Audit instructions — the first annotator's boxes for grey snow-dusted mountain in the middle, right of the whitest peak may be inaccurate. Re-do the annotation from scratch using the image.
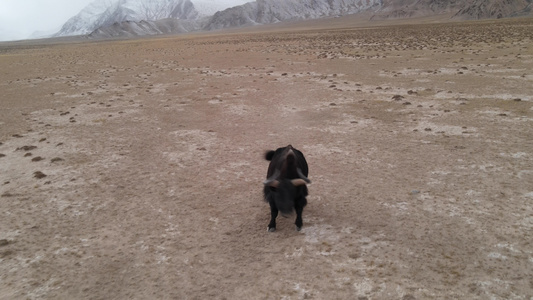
[204,0,383,30]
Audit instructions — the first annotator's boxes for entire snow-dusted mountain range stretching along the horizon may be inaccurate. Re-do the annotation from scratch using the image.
[58,0,533,38]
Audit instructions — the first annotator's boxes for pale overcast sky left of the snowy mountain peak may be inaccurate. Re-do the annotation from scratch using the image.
[0,0,93,41]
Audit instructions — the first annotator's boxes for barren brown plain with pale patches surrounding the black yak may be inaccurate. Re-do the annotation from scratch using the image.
[0,19,533,300]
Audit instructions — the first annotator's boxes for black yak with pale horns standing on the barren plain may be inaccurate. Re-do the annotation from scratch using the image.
[263,145,311,232]
